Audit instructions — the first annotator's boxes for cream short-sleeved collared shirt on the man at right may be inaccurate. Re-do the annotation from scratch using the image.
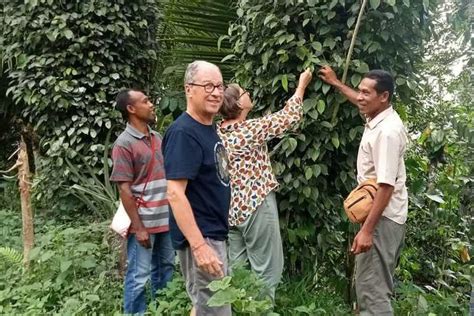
[357,107,408,224]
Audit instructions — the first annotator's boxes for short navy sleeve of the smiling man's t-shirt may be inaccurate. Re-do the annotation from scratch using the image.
[163,130,203,180]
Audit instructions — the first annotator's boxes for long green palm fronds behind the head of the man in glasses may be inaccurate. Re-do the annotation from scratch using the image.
[158,0,237,117]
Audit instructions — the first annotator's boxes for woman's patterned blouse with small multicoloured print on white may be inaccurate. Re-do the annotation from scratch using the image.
[217,95,303,226]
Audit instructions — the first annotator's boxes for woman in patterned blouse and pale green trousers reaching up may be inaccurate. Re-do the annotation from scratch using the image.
[218,70,312,301]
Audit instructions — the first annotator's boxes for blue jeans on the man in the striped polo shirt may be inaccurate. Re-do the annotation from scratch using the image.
[124,232,175,314]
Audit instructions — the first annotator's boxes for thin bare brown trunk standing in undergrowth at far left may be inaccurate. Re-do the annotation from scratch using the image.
[18,135,35,268]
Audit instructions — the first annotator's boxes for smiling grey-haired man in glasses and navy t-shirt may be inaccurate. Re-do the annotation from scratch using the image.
[163,61,231,316]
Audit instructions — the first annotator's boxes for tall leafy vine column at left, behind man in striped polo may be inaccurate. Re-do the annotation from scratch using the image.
[1,0,158,212]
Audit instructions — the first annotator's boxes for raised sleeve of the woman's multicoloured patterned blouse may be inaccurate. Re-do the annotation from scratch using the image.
[260,96,303,141]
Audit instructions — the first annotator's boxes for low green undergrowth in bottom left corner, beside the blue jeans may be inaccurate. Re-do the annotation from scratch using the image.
[0,217,122,315]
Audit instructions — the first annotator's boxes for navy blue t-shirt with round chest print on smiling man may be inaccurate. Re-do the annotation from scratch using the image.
[162,112,230,249]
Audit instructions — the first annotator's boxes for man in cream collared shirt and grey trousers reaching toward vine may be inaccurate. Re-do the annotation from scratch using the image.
[319,66,408,316]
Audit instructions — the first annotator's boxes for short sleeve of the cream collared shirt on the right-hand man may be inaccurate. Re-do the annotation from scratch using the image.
[372,130,405,186]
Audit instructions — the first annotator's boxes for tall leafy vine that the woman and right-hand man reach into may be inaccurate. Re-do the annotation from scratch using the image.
[224,0,442,292]
